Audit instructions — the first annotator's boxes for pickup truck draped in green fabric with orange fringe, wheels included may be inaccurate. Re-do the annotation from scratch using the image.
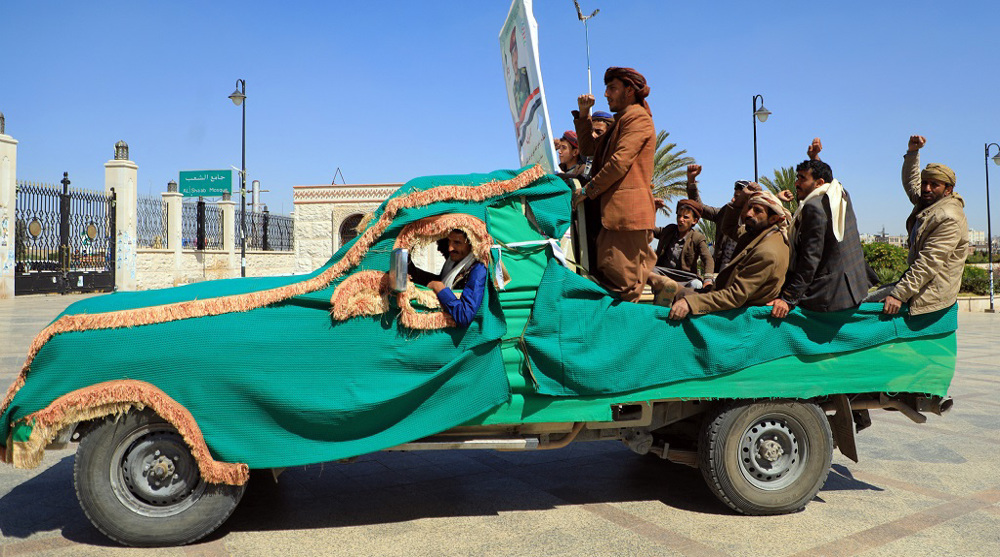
[0,168,957,546]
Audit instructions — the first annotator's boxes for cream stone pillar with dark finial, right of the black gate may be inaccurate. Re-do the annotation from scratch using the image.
[104,141,139,290]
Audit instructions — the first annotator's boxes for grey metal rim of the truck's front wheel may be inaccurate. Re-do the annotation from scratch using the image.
[110,423,206,517]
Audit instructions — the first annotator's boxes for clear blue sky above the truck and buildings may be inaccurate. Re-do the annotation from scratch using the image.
[0,0,1000,234]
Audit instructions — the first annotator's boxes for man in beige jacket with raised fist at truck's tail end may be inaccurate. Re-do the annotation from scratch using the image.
[882,135,969,315]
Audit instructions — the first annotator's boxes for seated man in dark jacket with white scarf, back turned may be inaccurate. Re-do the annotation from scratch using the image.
[768,138,871,318]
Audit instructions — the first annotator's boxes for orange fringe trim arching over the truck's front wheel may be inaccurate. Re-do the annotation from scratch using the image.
[5,379,250,485]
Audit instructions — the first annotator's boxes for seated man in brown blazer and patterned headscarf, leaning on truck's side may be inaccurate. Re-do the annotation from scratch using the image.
[670,191,789,320]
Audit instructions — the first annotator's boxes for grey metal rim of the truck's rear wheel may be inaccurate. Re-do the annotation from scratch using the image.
[739,414,809,491]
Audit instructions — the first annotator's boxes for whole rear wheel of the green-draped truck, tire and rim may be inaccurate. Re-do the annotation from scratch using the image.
[698,401,833,515]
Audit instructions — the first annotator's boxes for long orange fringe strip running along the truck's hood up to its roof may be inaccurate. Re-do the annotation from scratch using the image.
[0,165,544,422]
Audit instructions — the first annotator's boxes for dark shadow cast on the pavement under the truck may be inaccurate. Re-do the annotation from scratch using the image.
[0,443,881,545]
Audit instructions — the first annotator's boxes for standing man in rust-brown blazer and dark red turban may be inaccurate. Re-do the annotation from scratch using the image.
[574,68,656,302]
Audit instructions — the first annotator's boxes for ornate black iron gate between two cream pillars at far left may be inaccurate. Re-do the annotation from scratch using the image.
[14,172,115,295]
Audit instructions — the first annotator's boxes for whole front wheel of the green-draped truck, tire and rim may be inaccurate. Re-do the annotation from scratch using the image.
[73,410,246,547]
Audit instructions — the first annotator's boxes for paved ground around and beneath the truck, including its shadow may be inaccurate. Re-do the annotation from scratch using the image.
[0,297,1000,557]
